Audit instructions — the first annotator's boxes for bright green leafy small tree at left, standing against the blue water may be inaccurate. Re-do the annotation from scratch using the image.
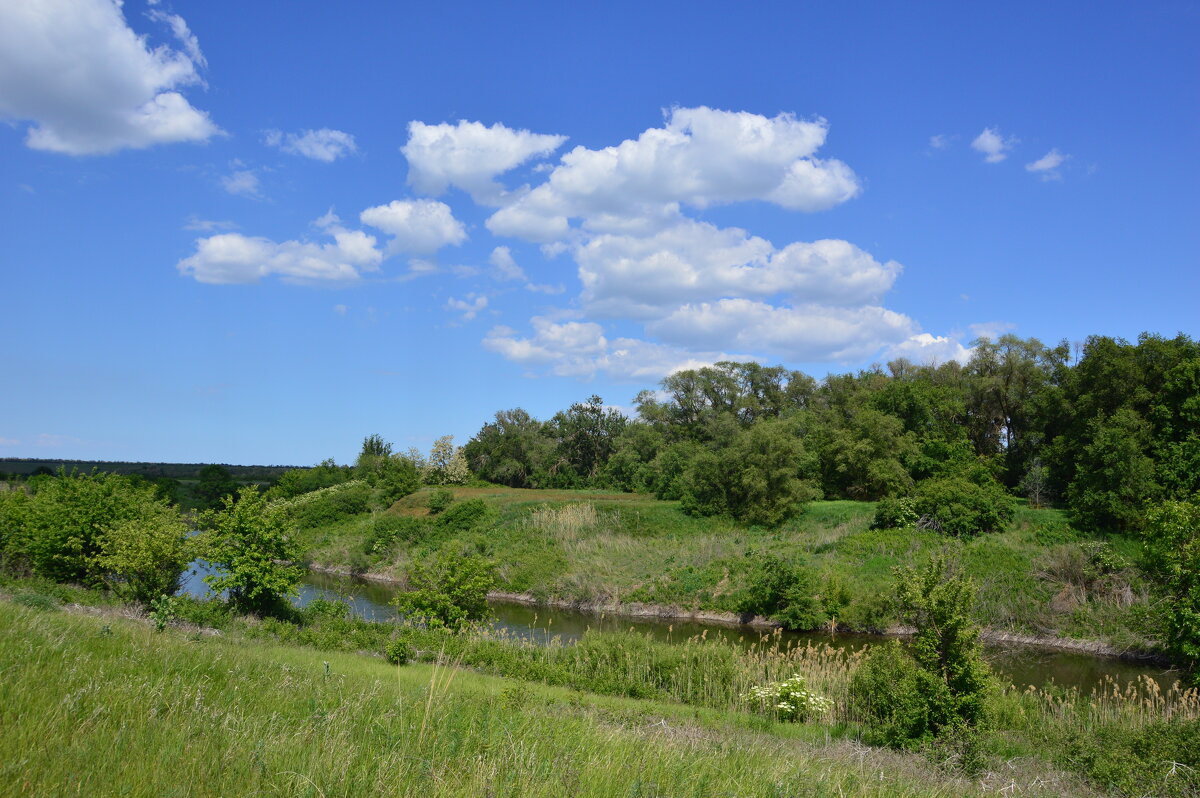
[200,487,302,612]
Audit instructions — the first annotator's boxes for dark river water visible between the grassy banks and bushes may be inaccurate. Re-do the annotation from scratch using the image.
[180,563,1178,692]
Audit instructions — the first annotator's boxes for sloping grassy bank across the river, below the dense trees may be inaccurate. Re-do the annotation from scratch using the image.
[297,487,1162,650]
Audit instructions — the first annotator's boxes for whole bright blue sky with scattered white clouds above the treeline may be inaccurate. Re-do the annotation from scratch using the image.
[0,0,1200,464]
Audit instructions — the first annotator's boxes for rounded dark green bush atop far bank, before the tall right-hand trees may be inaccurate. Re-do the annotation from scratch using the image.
[912,476,1016,535]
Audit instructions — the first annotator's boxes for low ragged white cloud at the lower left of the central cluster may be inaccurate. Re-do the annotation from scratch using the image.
[484,317,749,383]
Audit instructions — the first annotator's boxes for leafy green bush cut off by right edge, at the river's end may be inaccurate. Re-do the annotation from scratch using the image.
[1142,494,1200,667]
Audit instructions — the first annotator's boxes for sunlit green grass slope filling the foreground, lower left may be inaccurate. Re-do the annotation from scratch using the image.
[0,602,1091,798]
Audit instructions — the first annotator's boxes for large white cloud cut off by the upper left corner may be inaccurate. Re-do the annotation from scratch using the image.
[0,0,221,155]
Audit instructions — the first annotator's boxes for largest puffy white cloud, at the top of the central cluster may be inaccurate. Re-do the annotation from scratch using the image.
[487,107,859,241]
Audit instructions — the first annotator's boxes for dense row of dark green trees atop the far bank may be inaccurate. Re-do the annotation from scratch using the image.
[463,334,1200,534]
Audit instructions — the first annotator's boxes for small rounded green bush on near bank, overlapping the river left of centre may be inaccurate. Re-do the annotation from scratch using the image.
[392,550,496,630]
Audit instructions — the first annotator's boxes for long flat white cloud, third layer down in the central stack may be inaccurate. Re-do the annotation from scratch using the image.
[646,299,916,362]
